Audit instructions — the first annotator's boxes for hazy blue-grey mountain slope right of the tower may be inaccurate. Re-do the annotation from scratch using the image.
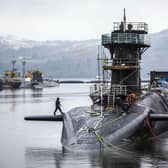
[142,29,168,77]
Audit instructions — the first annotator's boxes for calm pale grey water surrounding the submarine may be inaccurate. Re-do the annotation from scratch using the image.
[0,84,168,168]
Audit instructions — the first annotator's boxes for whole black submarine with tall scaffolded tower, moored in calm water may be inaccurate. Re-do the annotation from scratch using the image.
[61,9,168,151]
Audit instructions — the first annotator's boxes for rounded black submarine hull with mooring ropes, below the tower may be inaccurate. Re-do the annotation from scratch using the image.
[62,92,168,151]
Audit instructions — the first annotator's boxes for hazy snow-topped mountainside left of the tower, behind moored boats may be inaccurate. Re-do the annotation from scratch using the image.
[0,37,100,78]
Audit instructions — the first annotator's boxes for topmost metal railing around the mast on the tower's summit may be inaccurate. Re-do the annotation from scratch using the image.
[114,22,148,33]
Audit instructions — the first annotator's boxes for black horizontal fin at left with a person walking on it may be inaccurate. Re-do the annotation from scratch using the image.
[24,115,63,121]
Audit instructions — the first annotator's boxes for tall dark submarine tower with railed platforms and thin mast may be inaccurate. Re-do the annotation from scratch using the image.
[101,9,150,109]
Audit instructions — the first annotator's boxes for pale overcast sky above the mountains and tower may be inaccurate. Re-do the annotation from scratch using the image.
[0,0,168,40]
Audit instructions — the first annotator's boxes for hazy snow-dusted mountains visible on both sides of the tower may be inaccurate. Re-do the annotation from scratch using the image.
[0,29,168,78]
